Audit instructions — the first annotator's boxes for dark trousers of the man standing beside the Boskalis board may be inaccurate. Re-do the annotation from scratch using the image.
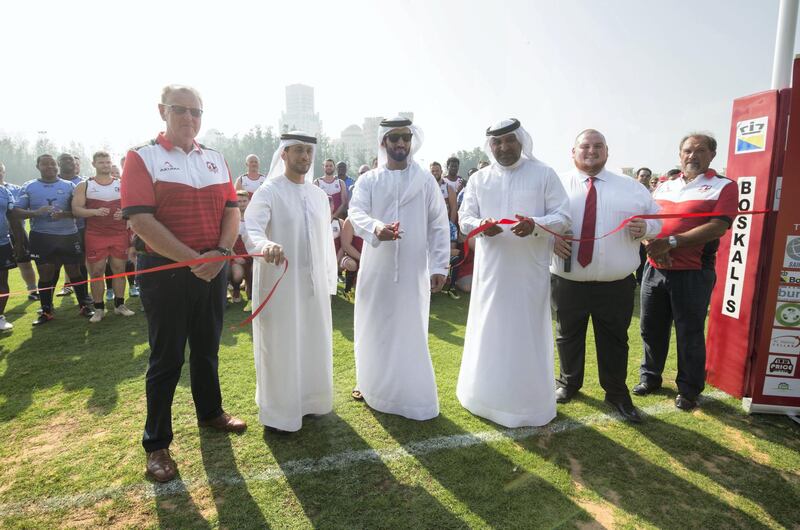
[639,263,717,399]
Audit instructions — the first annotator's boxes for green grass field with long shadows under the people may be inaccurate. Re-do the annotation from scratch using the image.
[0,271,800,528]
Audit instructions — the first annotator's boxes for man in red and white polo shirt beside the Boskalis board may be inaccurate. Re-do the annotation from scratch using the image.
[633,134,738,410]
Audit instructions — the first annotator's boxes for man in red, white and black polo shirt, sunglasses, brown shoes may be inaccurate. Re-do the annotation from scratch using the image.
[122,85,247,482]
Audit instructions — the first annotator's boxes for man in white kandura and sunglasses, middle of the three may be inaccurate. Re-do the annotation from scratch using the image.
[349,118,454,420]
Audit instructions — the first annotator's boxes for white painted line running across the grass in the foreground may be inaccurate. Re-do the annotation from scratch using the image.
[0,391,727,517]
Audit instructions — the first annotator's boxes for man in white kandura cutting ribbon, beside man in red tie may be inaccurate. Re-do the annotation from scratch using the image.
[456,119,570,427]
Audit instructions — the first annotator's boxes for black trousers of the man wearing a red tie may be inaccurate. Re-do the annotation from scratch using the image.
[550,274,636,403]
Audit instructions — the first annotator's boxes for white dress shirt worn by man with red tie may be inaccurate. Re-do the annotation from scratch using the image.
[550,169,661,282]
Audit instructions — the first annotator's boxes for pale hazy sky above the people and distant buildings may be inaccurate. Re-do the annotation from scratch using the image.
[0,0,800,170]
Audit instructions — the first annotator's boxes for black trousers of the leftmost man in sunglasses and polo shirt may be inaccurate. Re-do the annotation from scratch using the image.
[136,255,228,452]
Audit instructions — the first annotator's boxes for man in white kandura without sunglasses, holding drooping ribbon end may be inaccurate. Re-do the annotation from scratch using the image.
[244,132,336,431]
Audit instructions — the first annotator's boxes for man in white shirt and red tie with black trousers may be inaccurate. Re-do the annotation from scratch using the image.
[550,129,661,423]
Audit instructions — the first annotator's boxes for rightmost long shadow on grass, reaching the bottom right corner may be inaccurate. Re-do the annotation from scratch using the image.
[642,404,800,528]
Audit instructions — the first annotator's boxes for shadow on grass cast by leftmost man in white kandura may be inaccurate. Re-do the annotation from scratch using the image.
[264,413,467,528]
